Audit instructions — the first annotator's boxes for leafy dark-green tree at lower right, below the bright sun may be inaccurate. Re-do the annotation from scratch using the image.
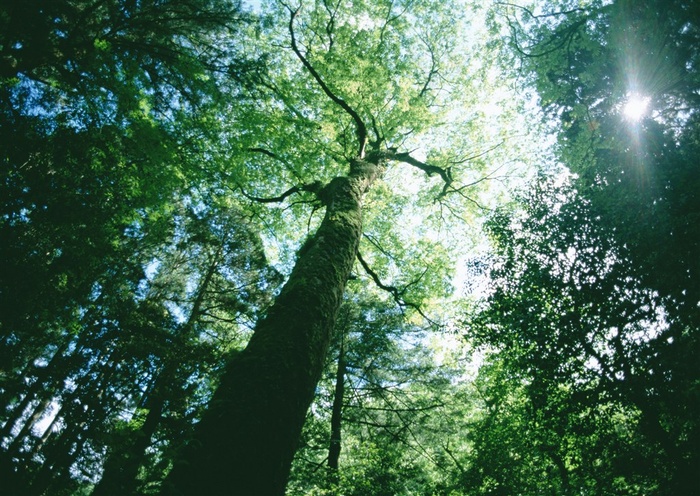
[469,181,680,494]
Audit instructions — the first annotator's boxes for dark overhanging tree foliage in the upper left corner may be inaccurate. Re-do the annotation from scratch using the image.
[0,1,258,384]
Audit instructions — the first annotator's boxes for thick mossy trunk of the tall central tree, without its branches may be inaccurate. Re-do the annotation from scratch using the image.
[163,159,383,496]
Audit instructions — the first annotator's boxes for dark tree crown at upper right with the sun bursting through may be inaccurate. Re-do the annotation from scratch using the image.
[494,1,700,306]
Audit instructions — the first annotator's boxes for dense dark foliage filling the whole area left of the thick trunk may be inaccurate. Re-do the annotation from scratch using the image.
[0,1,279,494]
